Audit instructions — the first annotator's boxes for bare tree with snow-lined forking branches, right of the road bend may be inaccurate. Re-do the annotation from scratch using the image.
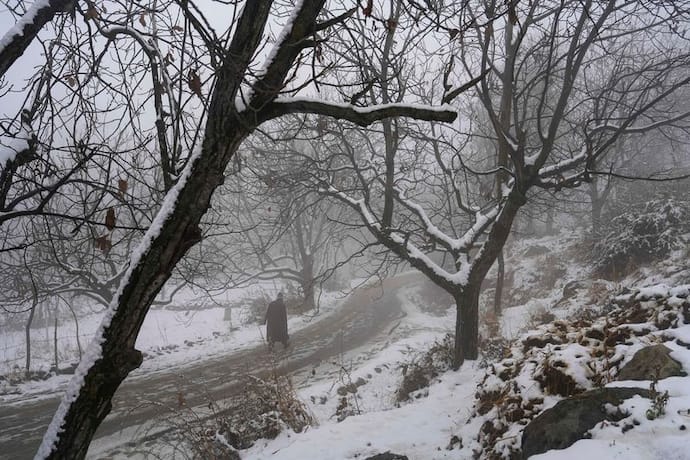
[310,1,690,367]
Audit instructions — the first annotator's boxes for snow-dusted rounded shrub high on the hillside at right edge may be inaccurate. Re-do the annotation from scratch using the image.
[592,199,690,279]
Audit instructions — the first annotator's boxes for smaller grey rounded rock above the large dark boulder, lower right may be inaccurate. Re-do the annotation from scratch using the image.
[617,344,687,380]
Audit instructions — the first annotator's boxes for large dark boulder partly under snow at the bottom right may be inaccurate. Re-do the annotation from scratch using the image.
[522,388,649,459]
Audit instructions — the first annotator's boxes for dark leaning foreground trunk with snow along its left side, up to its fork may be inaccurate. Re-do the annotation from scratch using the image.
[37,47,264,459]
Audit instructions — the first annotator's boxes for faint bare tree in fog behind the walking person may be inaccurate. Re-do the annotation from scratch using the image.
[209,135,347,310]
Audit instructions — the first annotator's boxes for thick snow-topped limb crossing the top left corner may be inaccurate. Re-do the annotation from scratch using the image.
[0,0,75,77]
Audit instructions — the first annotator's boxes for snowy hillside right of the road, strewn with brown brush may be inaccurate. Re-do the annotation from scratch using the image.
[234,235,690,460]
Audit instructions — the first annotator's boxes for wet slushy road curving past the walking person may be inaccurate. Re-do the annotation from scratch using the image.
[0,274,420,460]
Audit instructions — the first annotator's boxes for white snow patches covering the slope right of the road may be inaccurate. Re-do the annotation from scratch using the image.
[241,235,690,460]
